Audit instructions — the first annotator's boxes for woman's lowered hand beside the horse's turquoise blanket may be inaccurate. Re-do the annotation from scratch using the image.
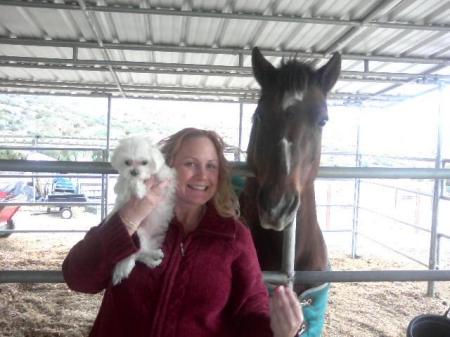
[270,286,303,337]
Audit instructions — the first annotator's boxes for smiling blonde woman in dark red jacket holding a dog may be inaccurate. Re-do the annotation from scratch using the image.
[63,128,303,337]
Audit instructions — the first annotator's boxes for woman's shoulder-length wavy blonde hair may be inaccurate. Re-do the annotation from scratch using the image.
[159,128,239,218]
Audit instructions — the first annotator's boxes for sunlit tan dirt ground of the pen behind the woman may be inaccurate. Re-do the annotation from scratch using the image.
[0,211,450,337]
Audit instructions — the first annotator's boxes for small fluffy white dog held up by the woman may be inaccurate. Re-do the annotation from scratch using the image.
[111,136,176,285]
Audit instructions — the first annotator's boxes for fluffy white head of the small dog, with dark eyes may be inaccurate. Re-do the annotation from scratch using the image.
[111,137,164,180]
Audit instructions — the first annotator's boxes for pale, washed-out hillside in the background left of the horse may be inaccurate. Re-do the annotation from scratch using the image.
[0,95,244,160]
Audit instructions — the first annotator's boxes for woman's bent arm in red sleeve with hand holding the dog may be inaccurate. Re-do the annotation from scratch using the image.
[62,177,173,293]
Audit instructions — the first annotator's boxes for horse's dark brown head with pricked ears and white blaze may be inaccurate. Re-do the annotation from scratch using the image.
[247,48,341,231]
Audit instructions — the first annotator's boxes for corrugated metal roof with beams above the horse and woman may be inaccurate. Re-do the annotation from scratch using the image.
[0,0,450,106]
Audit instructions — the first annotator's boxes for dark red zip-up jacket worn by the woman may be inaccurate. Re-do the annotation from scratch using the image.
[62,206,272,337]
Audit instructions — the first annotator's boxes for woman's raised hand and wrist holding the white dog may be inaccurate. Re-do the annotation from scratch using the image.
[119,177,169,235]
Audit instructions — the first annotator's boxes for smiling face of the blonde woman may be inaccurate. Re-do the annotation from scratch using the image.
[173,136,219,207]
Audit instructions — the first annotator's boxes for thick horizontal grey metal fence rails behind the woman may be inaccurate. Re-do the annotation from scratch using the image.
[0,160,450,283]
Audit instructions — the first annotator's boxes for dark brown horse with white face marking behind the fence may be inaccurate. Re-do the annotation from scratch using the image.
[240,47,341,294]
